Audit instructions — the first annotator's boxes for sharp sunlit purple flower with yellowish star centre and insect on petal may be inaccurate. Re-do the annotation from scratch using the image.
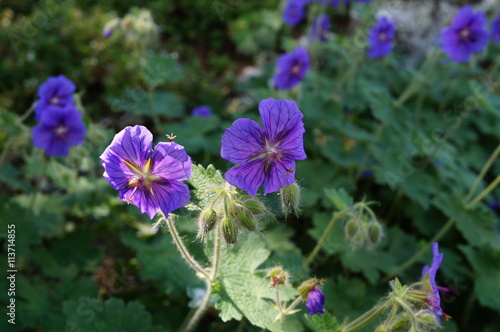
[100,126,191,219]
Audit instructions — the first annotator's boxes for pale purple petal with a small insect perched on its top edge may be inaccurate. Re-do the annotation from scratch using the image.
[152,142,192,181]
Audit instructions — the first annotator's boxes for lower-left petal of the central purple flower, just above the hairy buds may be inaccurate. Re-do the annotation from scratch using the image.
[224,158,266,196]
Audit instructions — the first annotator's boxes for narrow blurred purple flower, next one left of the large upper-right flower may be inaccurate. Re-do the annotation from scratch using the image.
[368,16,396,59]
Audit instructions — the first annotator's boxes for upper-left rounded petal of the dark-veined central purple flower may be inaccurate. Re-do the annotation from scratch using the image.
[220,119,265,164]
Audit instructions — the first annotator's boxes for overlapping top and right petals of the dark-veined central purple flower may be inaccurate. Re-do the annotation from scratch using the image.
[259,98,306,160]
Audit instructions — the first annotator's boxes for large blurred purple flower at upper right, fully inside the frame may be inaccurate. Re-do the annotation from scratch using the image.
[441,6,489,62]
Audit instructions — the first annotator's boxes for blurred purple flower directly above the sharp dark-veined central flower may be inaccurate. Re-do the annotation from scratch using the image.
[274,47,311,90]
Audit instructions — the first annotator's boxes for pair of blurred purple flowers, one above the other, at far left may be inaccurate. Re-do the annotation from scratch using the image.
[31,75,87,156]
